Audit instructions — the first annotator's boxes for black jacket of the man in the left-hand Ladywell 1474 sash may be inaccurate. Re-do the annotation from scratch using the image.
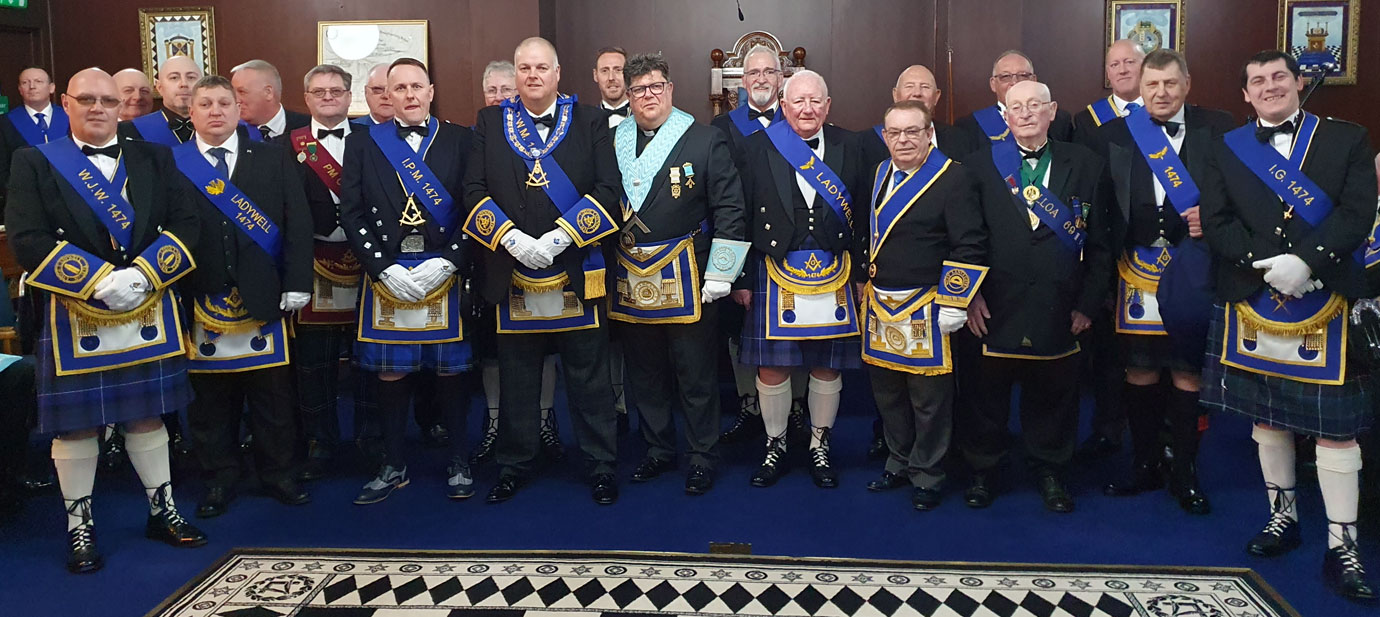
[178,137,312,322]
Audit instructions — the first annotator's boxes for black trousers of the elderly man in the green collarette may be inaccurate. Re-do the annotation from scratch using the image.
[959,353,1082,473]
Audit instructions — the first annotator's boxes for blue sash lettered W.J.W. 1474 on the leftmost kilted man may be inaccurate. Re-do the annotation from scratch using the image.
[37,137,134,248]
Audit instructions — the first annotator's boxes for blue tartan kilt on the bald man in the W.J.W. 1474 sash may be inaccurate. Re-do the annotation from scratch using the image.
[35,322,192,433]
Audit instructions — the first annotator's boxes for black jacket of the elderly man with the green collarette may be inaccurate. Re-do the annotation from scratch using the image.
[965,139,1112,355]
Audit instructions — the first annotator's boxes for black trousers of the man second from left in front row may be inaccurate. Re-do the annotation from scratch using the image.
[186,366,297,487]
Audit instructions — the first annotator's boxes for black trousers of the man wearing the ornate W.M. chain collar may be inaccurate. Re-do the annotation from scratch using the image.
[494,306,609,478]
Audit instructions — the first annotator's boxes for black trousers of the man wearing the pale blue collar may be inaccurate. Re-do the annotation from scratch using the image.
[613,302,719,469]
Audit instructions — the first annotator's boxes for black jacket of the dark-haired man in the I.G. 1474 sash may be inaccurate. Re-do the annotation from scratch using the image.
[1198,119,1376,302]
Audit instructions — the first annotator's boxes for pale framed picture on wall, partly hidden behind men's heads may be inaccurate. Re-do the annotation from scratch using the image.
[316,19,431,116]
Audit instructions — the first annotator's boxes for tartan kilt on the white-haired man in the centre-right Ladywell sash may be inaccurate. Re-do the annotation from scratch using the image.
[738,268,863,370]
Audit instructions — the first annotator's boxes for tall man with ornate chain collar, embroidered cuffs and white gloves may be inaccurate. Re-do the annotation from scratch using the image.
[465,37,621,504]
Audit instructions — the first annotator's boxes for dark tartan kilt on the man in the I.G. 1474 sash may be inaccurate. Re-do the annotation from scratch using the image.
[1199,304,1374,440]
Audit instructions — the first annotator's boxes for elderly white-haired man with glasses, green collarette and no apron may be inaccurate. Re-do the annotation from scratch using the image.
[959,81,1111,512]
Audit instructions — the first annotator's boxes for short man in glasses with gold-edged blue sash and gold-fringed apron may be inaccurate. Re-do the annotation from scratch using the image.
[854,101,987,511]
